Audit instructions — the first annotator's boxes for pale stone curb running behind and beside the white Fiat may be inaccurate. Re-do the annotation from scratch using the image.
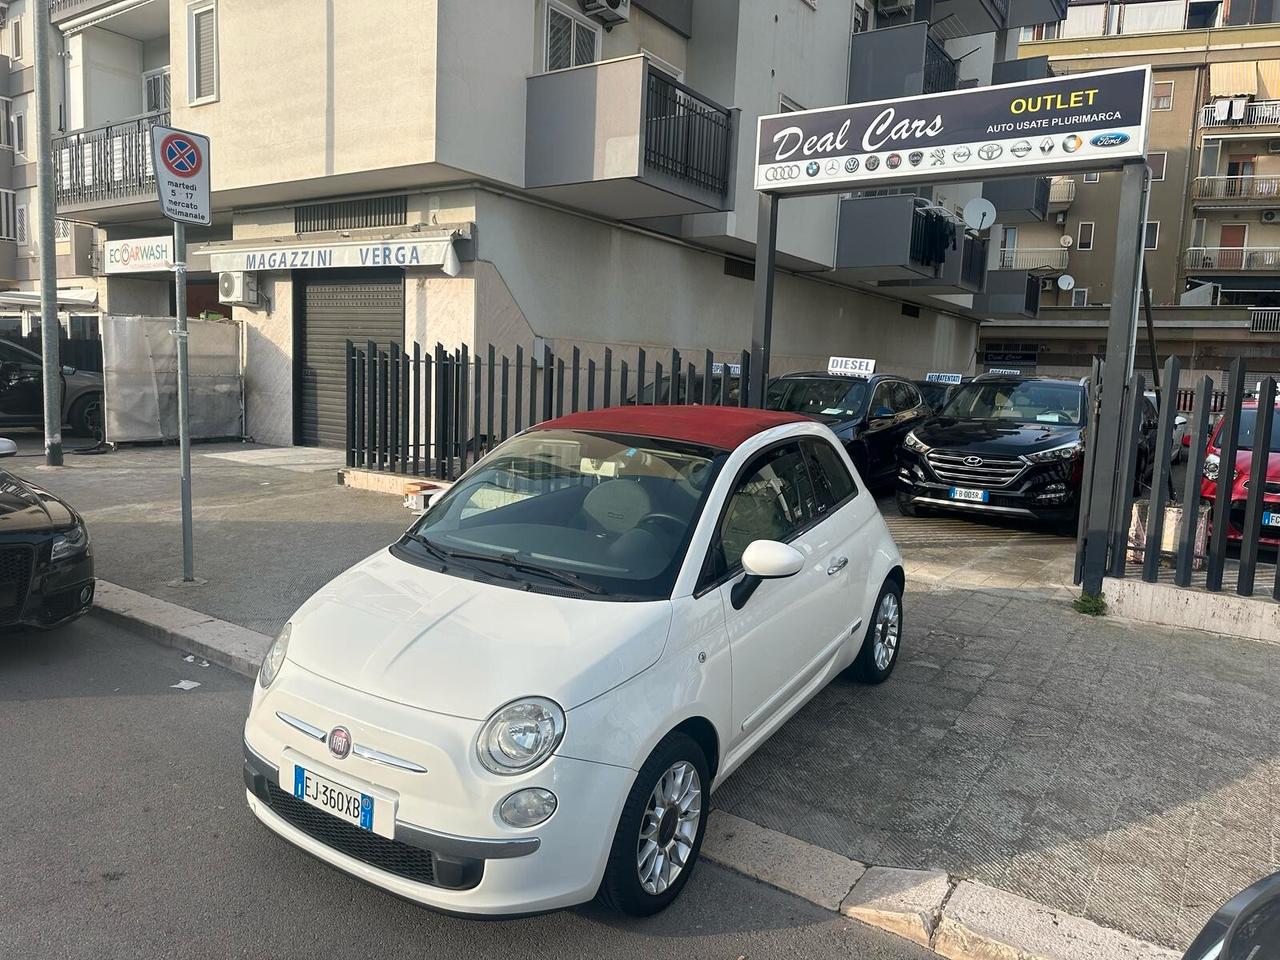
[92,580,1180,960]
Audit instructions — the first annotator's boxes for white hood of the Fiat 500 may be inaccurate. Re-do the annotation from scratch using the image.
[288,550,672,721]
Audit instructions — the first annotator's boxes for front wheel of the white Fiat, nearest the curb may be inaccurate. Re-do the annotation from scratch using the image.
[596,731,710,916]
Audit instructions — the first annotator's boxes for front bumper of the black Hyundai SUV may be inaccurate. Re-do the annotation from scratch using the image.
[897,449,1080,521]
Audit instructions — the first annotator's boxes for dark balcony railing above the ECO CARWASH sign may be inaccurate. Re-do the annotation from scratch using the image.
[54,111,169,207]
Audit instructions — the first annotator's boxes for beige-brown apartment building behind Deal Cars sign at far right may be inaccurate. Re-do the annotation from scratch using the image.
[979,0,1280,376]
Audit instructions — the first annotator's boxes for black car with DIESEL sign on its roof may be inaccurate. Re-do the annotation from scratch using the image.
[764,371,932,486]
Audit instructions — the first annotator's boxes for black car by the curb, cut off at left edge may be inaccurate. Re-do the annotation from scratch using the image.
[0,440,93,634]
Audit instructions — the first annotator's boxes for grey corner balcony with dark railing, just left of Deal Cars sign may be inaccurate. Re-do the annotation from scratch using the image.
[525,55,735,220]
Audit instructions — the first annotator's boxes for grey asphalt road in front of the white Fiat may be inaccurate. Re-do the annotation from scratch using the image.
[0,618,933,960]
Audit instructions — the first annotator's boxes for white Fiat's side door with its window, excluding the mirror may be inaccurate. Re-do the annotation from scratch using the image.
[710,440,850,744]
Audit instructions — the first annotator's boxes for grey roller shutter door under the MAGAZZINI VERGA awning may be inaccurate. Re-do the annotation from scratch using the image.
[294,270,404,447]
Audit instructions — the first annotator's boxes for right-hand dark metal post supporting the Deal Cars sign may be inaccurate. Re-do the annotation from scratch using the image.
[1080,161,1149,596]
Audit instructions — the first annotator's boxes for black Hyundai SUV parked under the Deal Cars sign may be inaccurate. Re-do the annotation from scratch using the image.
[897,375,1156,526]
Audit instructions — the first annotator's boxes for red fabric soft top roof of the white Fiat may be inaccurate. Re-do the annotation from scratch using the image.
[535,404,813,451]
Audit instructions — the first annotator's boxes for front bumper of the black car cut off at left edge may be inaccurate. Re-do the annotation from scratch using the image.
[0,545,95,630]
